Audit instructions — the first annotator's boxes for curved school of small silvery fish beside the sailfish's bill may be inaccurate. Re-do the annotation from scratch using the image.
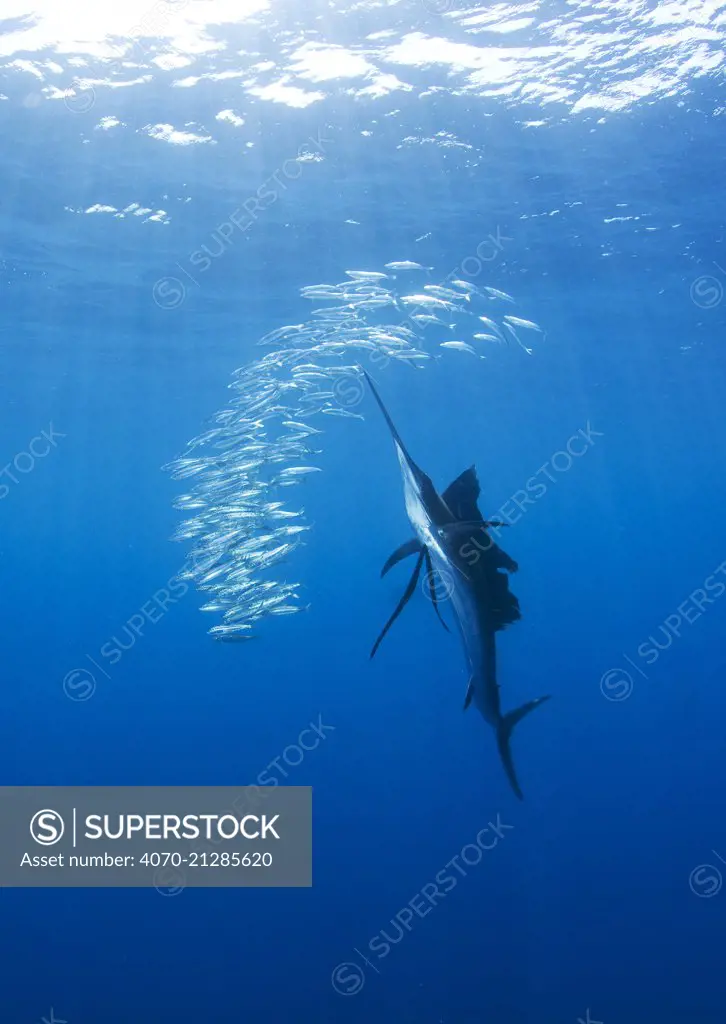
[164,260,540,643]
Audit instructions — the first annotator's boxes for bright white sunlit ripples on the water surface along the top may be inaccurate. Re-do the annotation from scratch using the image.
[0,0,726,112]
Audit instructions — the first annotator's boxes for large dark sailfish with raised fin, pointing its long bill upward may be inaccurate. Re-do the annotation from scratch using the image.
[362,370,550,800]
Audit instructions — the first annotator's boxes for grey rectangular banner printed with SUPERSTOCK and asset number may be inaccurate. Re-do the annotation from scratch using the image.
[0,785,312,895]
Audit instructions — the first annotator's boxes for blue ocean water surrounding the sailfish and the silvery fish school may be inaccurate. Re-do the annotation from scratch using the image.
[0,0,726,1024]
